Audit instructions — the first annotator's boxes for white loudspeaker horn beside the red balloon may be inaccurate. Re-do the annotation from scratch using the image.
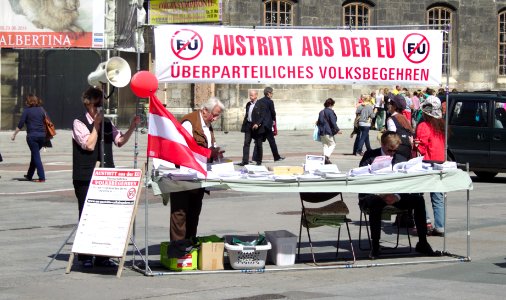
[88,56,132,87]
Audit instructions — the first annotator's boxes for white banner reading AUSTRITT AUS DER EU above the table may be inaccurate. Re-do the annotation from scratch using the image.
[155,25,443,85]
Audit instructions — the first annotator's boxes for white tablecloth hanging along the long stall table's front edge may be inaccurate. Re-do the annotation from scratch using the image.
[152,169,473,195]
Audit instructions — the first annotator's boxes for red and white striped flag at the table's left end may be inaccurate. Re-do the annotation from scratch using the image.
[147,95,211,177]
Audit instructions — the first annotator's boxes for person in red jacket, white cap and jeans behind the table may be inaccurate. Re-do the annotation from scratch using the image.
[415,96,445,236]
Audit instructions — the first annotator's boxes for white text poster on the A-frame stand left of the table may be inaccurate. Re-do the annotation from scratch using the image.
[72,168,142,257]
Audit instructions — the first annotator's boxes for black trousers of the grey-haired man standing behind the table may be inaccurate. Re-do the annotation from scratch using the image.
[170,189,204,241]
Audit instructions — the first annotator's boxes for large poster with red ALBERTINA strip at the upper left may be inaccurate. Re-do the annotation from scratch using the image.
[0,0,105,48]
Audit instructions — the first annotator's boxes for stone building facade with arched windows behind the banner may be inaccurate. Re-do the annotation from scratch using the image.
[1,0,506,130]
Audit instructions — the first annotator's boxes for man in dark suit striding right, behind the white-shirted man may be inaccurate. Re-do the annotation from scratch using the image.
[253,87,285,164]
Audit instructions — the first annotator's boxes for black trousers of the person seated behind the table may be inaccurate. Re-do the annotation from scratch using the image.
[359,194,427,244]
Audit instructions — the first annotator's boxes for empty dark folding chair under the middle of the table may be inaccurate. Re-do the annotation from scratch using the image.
[297,193,356,265]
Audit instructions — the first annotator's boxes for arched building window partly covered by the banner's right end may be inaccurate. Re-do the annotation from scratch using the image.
[427,6,453,75]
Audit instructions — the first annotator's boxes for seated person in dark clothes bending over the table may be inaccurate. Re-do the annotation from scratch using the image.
[358,131,440,259]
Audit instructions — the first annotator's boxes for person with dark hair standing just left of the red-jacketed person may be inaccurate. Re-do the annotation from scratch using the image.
[387,94,413,160]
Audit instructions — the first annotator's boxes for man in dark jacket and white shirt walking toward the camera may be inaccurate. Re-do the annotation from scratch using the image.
[239,90,265,166]
